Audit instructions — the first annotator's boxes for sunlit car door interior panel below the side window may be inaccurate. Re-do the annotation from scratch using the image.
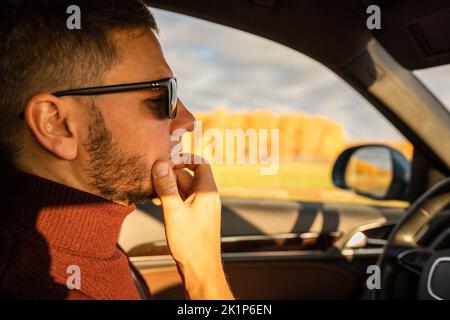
[120,198,403,299]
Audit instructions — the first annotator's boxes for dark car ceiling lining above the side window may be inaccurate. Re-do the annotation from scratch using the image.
[147,0,450,71]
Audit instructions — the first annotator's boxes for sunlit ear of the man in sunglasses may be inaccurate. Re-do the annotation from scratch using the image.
[24,93,78,160]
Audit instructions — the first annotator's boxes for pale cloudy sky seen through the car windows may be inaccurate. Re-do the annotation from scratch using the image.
[152,9,450,141]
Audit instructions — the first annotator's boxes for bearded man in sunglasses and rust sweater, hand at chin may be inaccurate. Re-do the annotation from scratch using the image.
[0,0,233,299]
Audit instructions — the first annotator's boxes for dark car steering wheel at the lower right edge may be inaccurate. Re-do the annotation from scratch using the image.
[372,178,450,300]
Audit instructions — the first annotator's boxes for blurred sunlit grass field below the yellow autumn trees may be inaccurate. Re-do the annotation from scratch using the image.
[213,162,407,206]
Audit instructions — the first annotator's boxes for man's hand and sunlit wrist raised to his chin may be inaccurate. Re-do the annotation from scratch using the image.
[152,156,233,299]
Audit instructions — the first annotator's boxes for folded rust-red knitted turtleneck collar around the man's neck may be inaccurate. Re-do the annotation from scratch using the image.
[0,168,135,258]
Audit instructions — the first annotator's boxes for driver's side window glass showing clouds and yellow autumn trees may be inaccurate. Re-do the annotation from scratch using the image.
[153,10,412,205]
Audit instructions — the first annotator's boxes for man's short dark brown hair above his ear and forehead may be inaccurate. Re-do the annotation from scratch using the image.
[0,0,157,162]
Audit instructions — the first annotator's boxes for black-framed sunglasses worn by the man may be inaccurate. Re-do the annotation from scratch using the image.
[19,77,178,119]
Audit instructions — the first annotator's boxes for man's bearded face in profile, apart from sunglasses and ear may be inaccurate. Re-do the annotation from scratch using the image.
[76,31,195,203]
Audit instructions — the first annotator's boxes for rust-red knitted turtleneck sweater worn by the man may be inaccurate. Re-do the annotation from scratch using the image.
[0,169,140,299]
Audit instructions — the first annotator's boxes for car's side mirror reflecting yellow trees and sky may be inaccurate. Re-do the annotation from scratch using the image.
[333,144,411,200]
